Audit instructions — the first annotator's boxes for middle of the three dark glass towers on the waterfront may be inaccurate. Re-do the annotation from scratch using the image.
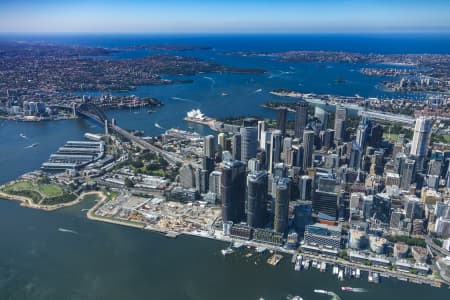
[247,172,268,228]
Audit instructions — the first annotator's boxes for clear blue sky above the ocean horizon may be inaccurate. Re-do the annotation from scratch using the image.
[0,0,450,33]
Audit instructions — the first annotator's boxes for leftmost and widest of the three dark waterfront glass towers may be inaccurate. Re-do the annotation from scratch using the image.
[220,160,246,223]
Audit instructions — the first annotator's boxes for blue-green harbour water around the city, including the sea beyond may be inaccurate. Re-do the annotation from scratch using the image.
[0,36,450,300]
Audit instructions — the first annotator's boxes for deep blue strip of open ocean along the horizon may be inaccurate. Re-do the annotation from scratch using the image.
[0,33,450,53]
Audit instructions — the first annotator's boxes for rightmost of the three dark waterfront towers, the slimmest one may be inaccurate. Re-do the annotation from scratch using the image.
[273,178,290,234]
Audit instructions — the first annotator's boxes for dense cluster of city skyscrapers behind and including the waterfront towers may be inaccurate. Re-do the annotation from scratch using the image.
[178,102,450,252]
